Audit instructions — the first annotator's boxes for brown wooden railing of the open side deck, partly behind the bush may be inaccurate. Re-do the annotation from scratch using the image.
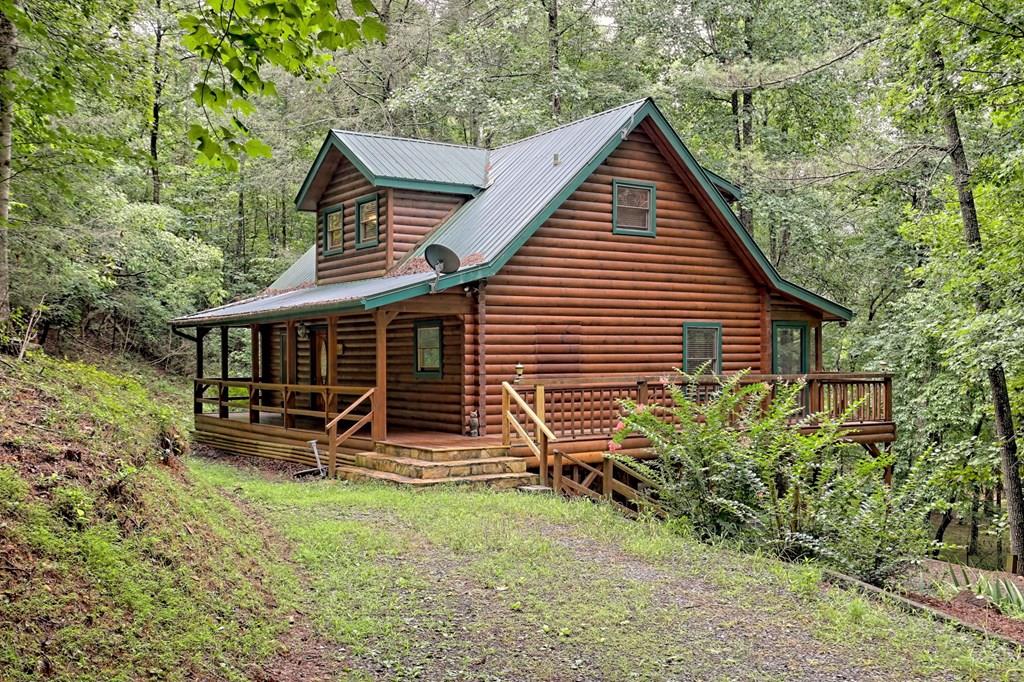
[503,373,892,440]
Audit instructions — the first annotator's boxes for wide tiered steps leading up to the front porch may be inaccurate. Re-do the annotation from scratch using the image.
[338,442,538,489]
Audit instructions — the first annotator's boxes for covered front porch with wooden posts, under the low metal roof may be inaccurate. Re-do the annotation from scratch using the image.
[179,295,476,470]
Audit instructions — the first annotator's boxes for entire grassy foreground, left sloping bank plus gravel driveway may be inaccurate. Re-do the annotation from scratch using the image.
[0,354,1024,682]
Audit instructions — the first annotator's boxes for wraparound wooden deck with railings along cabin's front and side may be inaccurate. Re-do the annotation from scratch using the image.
[195,373,896,475]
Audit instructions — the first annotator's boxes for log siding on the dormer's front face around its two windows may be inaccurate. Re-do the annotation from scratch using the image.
[316,159,388,284]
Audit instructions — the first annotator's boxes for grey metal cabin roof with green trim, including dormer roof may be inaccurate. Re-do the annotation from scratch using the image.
[174,98,853,326]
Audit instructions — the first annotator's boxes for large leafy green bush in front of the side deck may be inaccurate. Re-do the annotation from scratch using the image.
[613,373,936,585]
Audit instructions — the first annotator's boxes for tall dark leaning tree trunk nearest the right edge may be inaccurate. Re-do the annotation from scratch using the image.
[935,63,1024,574]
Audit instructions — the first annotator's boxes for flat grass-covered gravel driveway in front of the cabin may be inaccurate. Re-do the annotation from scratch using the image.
[188,458,1024,680]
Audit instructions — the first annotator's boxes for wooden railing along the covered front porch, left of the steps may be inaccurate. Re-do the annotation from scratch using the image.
[194,377,368,428]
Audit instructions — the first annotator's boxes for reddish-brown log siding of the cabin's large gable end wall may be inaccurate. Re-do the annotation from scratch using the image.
[479,130,767,433]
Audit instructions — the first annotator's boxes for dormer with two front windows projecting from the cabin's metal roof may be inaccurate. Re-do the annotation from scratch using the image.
[295,130,488,284]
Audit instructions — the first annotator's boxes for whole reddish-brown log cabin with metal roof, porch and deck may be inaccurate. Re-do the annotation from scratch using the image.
[172,99,896,486]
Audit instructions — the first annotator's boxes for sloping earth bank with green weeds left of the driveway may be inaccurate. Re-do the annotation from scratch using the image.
[0,353,297,682]
